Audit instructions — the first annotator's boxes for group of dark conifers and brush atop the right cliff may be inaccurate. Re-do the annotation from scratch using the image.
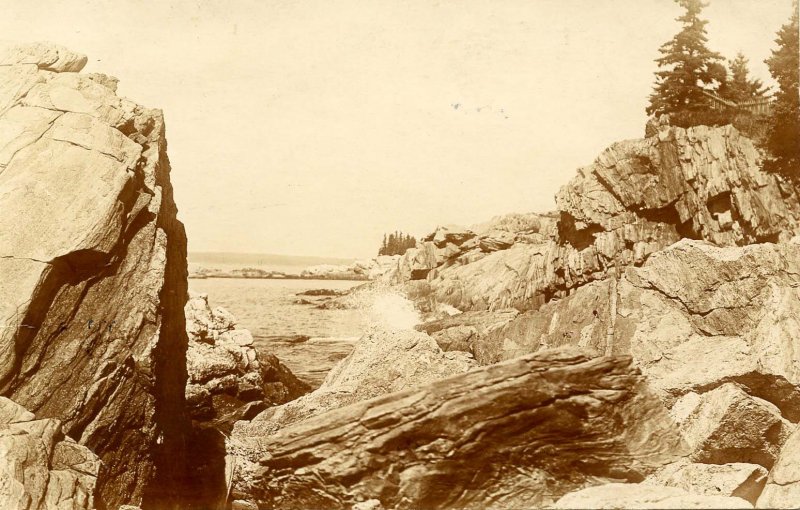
[646,0,800,179]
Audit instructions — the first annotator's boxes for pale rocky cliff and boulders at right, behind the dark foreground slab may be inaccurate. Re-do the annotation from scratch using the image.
[360,124,800,508]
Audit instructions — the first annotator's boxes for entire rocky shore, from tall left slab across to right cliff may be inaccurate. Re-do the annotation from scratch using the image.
[0,44,800,510]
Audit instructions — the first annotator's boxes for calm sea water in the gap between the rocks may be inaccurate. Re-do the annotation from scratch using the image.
[189,278,364,387]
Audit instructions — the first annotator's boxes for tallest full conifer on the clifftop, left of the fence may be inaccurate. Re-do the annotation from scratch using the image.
[647,0,726,115]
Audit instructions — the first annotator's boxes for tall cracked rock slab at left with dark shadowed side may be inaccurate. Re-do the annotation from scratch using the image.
[0,44,188,508]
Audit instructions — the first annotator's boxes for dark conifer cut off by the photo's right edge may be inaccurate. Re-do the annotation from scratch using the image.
[765,0,800,183]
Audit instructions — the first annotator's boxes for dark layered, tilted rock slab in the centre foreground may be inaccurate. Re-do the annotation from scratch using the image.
[234,351,688,509]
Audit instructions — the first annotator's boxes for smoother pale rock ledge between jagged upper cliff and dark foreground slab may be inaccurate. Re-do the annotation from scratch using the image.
[462,240,800,422]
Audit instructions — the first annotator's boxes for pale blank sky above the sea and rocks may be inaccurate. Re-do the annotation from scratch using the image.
[0,0,792,257]
